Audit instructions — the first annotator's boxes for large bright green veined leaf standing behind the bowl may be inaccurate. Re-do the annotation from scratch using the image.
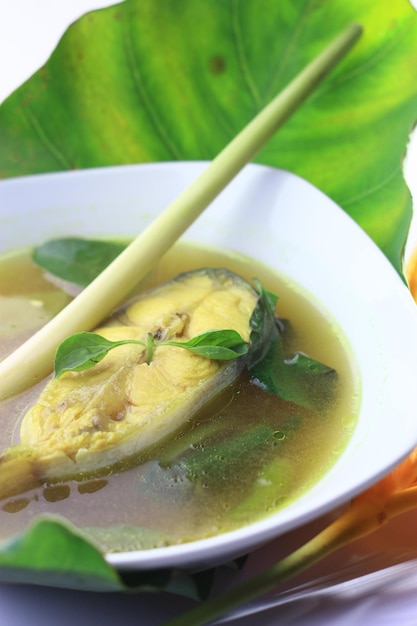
[0,0,417,269]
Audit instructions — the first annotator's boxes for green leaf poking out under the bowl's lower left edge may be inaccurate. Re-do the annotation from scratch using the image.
[0,516,214,600]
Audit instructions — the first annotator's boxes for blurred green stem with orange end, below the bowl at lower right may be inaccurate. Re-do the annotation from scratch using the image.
[161,486,417,626]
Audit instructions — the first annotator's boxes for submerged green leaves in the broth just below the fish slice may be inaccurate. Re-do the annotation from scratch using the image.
[159,411,304,518]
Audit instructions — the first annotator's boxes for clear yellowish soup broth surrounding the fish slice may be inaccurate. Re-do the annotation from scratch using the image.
[0,244,359,551]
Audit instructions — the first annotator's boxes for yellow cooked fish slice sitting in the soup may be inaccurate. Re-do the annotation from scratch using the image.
[0,269,258,498]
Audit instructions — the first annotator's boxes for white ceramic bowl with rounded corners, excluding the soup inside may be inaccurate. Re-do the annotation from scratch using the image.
[0,162,417,569]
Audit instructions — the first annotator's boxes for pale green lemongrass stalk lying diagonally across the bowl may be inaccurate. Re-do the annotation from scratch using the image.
[0,24,362,399]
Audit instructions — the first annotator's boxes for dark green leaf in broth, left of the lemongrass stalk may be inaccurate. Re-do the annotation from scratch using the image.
[32,237,126,287]
